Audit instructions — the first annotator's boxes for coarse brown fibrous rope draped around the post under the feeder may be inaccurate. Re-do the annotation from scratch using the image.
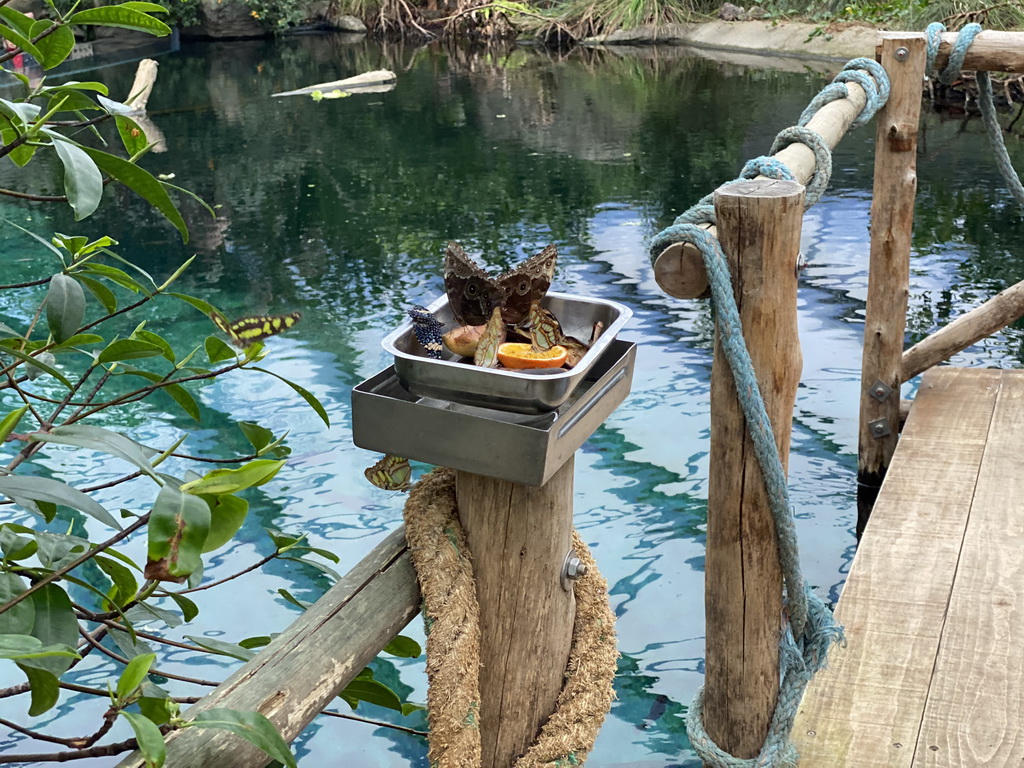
[406,469,618,768]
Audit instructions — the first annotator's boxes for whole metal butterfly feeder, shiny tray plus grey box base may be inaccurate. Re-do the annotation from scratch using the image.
[352,294,636,486]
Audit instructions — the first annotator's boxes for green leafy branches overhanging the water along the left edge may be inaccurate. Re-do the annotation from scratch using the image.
[0,1,419,766]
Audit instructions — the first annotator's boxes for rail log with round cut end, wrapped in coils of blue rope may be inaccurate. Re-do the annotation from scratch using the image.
[654,78,867,299]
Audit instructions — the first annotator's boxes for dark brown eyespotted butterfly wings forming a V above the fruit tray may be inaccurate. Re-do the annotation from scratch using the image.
[444,243,558,326]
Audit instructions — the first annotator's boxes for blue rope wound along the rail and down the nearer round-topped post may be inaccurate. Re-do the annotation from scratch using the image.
[651,59,889,768]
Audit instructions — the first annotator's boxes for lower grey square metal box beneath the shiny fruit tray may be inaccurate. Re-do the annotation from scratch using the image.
[352,339,636,486]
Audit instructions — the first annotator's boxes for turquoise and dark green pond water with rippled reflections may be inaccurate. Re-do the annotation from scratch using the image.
[0,31,1024,768]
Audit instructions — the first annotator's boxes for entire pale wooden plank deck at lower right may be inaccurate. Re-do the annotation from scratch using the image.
[794,368,1024,768]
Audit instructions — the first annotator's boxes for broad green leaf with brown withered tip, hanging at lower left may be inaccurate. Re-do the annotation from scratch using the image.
[145,484,210,581]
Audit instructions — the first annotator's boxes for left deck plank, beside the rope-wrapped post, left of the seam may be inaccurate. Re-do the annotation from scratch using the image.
[794,368,1001,768]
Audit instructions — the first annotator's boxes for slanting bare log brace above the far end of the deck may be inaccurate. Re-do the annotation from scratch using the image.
[900,281,1024,381]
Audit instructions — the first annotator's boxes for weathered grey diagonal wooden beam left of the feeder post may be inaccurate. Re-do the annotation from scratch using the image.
[117,526,420,768]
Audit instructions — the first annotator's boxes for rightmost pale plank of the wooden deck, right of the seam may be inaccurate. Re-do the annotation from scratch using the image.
[913,371,1024,768]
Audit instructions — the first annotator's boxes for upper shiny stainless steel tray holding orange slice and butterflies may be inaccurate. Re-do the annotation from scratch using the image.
[381,291,633,414]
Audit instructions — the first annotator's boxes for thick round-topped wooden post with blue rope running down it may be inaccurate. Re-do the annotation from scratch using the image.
[703,179,804,758]
